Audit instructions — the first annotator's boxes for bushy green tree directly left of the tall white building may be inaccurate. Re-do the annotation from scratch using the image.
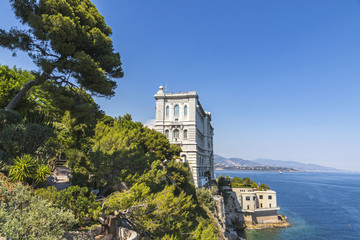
[83,114,181,194]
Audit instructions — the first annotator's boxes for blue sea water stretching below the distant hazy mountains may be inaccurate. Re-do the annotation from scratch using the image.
[215,171,360,240]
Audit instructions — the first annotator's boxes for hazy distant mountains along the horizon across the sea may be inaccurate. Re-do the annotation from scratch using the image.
[214,154,340,171]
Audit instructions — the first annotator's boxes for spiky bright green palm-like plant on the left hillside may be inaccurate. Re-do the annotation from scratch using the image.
[9,154,50,186]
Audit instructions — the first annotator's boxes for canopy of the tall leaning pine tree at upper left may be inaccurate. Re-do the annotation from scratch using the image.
[0,0,123,109]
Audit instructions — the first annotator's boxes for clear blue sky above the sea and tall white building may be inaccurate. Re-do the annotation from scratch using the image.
[0,0,360,171]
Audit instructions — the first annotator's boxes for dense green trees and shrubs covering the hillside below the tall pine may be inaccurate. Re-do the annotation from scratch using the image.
[0,66,218,239]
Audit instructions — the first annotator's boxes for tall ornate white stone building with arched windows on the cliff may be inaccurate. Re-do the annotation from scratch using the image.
[154,86,214,187]
